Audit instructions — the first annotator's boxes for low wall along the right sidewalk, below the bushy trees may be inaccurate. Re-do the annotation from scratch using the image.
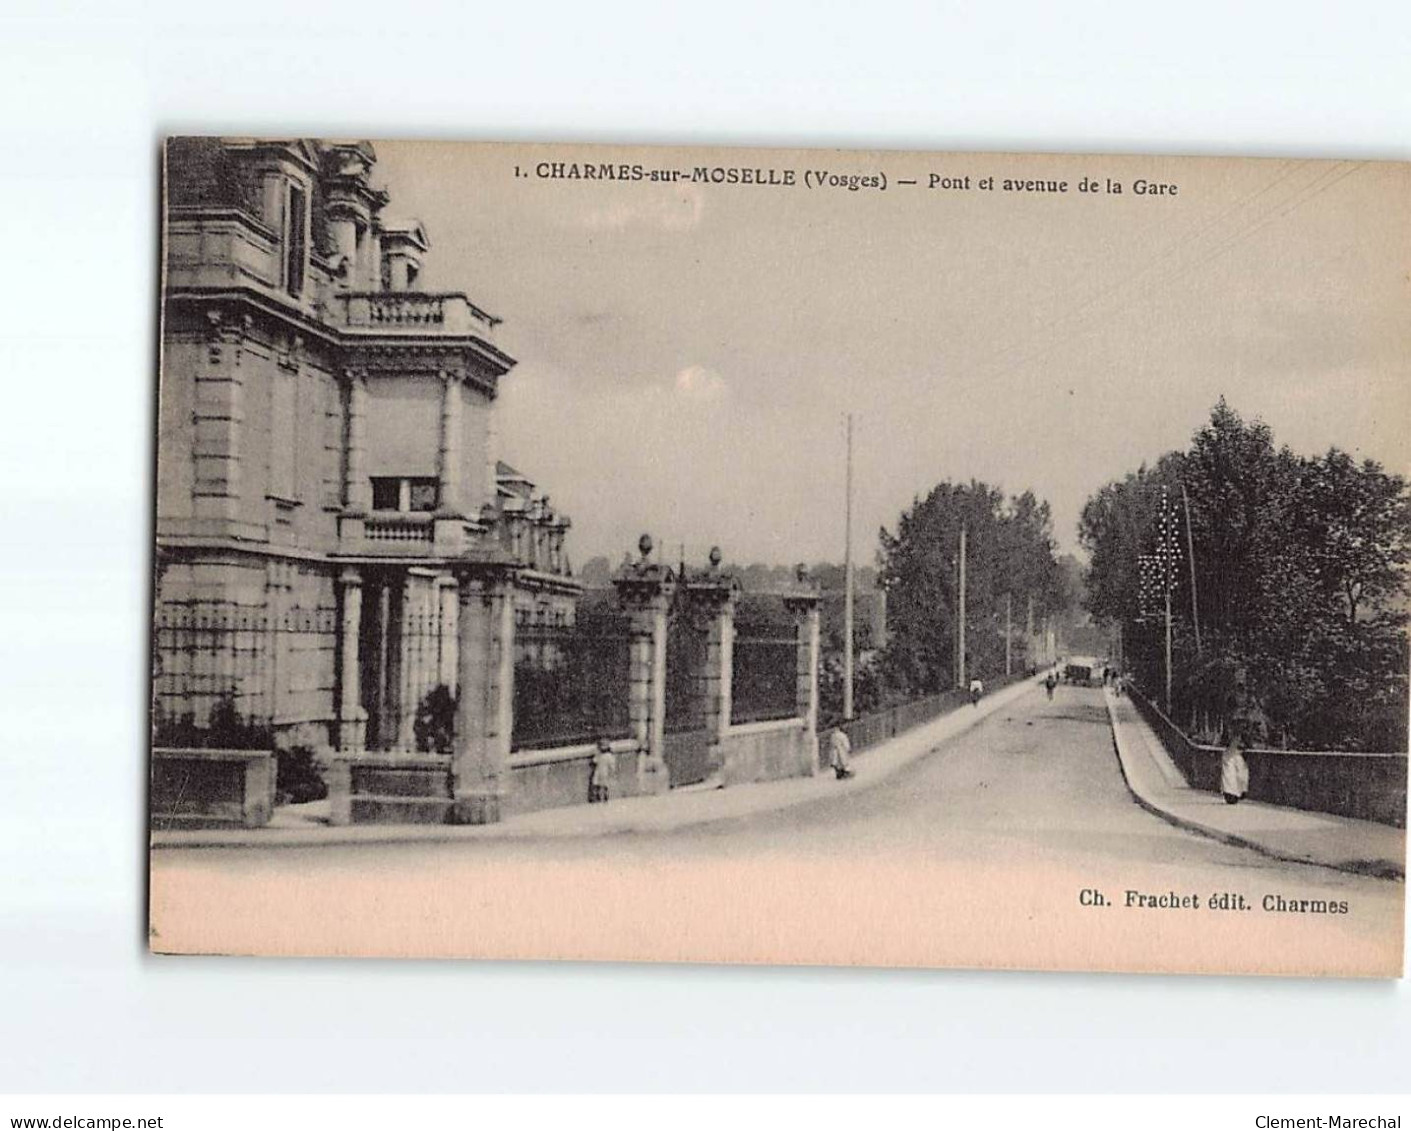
[1130,691,1407,828]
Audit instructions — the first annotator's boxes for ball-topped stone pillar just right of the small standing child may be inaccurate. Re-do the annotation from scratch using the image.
[612,534,673,793]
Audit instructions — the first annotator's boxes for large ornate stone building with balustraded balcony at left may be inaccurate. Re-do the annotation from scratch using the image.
[154,138,577,753]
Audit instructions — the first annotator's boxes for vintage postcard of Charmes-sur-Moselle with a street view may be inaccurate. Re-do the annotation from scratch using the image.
[150,137,1411,977]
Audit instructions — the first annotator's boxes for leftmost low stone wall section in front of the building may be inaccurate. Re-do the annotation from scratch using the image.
[151,747,275,829]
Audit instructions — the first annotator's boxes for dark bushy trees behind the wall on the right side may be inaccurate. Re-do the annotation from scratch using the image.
[1079,399,1411,750]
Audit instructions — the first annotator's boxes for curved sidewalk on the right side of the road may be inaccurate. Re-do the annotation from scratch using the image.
[1102,679,1407,880]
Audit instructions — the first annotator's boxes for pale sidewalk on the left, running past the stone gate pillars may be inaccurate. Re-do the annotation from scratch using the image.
[151,680,1038,848]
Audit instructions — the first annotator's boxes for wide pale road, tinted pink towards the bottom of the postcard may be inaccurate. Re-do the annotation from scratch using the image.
[152,688,1404,973]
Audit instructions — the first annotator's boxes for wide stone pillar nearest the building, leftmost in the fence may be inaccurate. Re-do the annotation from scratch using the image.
[452,566,515,825]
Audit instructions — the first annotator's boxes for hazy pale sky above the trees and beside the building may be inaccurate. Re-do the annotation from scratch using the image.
[375,141,1411,564]
